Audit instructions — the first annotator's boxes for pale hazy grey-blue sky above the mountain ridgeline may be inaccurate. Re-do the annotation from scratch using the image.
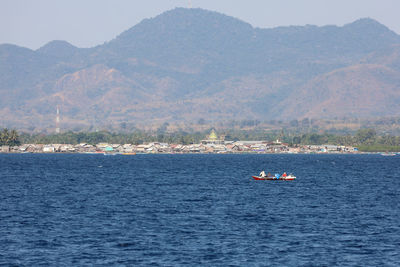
[0,0,400,49]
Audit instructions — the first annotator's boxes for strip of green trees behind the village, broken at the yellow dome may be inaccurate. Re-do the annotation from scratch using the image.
[0,128,400,152]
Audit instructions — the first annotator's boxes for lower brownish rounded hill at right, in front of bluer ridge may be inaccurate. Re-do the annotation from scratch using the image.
[282,64,400,118]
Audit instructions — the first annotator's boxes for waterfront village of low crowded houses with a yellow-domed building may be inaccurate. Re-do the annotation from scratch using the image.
[0,130,358,155]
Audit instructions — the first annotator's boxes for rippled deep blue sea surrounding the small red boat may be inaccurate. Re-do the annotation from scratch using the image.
[0,154,400,266]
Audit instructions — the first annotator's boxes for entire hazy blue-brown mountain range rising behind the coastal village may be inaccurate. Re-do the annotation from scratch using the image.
[0,8,400,131]
